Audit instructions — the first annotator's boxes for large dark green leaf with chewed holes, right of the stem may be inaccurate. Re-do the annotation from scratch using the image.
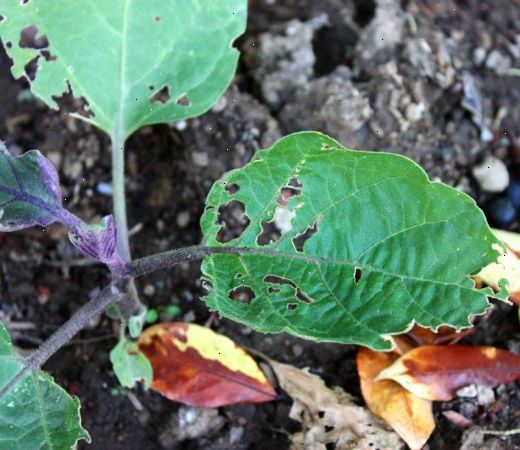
[201,132,498,350]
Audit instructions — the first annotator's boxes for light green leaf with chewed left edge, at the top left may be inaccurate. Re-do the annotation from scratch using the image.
[0,0,247,137]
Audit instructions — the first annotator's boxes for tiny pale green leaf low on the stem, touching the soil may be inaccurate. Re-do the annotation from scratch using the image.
[110,338,153,388]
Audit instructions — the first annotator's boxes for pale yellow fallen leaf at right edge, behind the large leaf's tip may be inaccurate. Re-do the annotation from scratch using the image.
[477,230,520,305]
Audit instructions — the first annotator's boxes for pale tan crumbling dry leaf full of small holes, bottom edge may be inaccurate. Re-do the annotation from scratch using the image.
[270,361,403,450]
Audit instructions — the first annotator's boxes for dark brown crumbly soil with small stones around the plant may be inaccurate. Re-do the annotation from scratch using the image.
[0,0,520,450]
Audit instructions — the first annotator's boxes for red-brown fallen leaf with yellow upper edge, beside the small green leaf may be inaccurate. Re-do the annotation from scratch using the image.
[139,322,276,408]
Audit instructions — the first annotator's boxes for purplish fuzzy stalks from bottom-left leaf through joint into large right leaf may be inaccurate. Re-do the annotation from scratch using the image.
[0,246,273,398]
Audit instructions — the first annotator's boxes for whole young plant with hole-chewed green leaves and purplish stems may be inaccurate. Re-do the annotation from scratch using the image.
[0,0,508,448]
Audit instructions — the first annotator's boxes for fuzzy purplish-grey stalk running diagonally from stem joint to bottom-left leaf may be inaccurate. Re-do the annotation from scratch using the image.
[0,277,129,398]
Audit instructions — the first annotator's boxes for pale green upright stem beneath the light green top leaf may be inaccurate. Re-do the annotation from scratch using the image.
[112,130,142,322]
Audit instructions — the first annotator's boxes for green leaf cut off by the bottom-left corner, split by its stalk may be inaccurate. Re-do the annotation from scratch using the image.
[0,323,90,450]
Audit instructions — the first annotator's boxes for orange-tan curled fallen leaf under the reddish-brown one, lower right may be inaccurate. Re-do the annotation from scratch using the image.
[357,347,435,450]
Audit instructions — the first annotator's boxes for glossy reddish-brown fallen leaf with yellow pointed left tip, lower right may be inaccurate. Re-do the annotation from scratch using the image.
[376,345,520,400]
